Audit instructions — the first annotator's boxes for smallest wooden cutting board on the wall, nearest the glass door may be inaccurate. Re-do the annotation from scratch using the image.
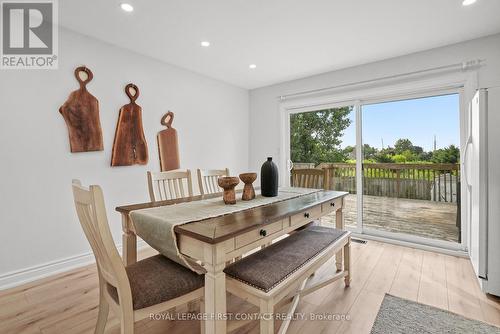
[157,111,180,172]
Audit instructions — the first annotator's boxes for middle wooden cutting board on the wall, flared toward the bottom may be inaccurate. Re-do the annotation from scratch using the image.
[111,84,148,166]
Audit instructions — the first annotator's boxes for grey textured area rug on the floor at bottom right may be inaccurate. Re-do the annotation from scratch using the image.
[371,294,500,334]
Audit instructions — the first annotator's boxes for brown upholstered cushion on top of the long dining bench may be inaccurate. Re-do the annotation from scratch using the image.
[224,225,348,292]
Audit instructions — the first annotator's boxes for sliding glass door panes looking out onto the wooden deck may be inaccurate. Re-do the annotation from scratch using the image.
[286,93,461,248]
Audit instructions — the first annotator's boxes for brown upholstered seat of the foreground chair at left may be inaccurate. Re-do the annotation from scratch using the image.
[108,255,205,310]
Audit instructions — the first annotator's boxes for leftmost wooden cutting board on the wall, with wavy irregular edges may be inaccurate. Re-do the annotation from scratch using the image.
[59,66,104,153]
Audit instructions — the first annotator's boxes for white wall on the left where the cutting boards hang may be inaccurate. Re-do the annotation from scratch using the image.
[0,31,249,286]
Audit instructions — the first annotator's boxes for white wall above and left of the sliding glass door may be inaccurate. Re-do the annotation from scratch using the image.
[249,34,500,172]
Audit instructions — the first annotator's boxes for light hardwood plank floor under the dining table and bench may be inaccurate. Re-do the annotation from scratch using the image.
[0,241,500,334]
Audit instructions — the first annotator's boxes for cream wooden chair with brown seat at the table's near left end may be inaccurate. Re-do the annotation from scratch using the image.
[73,180,204,334]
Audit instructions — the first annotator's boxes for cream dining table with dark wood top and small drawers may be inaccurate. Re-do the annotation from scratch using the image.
[116,188,348,334]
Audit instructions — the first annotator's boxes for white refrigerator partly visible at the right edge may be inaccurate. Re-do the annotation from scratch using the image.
[462,88,500,296]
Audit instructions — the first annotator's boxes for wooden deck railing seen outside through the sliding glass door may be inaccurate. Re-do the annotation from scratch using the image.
[292,163,460,203]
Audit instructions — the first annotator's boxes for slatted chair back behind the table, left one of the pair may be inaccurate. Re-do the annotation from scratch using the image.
[148,169,193,202]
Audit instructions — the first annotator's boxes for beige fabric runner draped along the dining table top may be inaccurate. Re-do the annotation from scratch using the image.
[130,187,319,274]
